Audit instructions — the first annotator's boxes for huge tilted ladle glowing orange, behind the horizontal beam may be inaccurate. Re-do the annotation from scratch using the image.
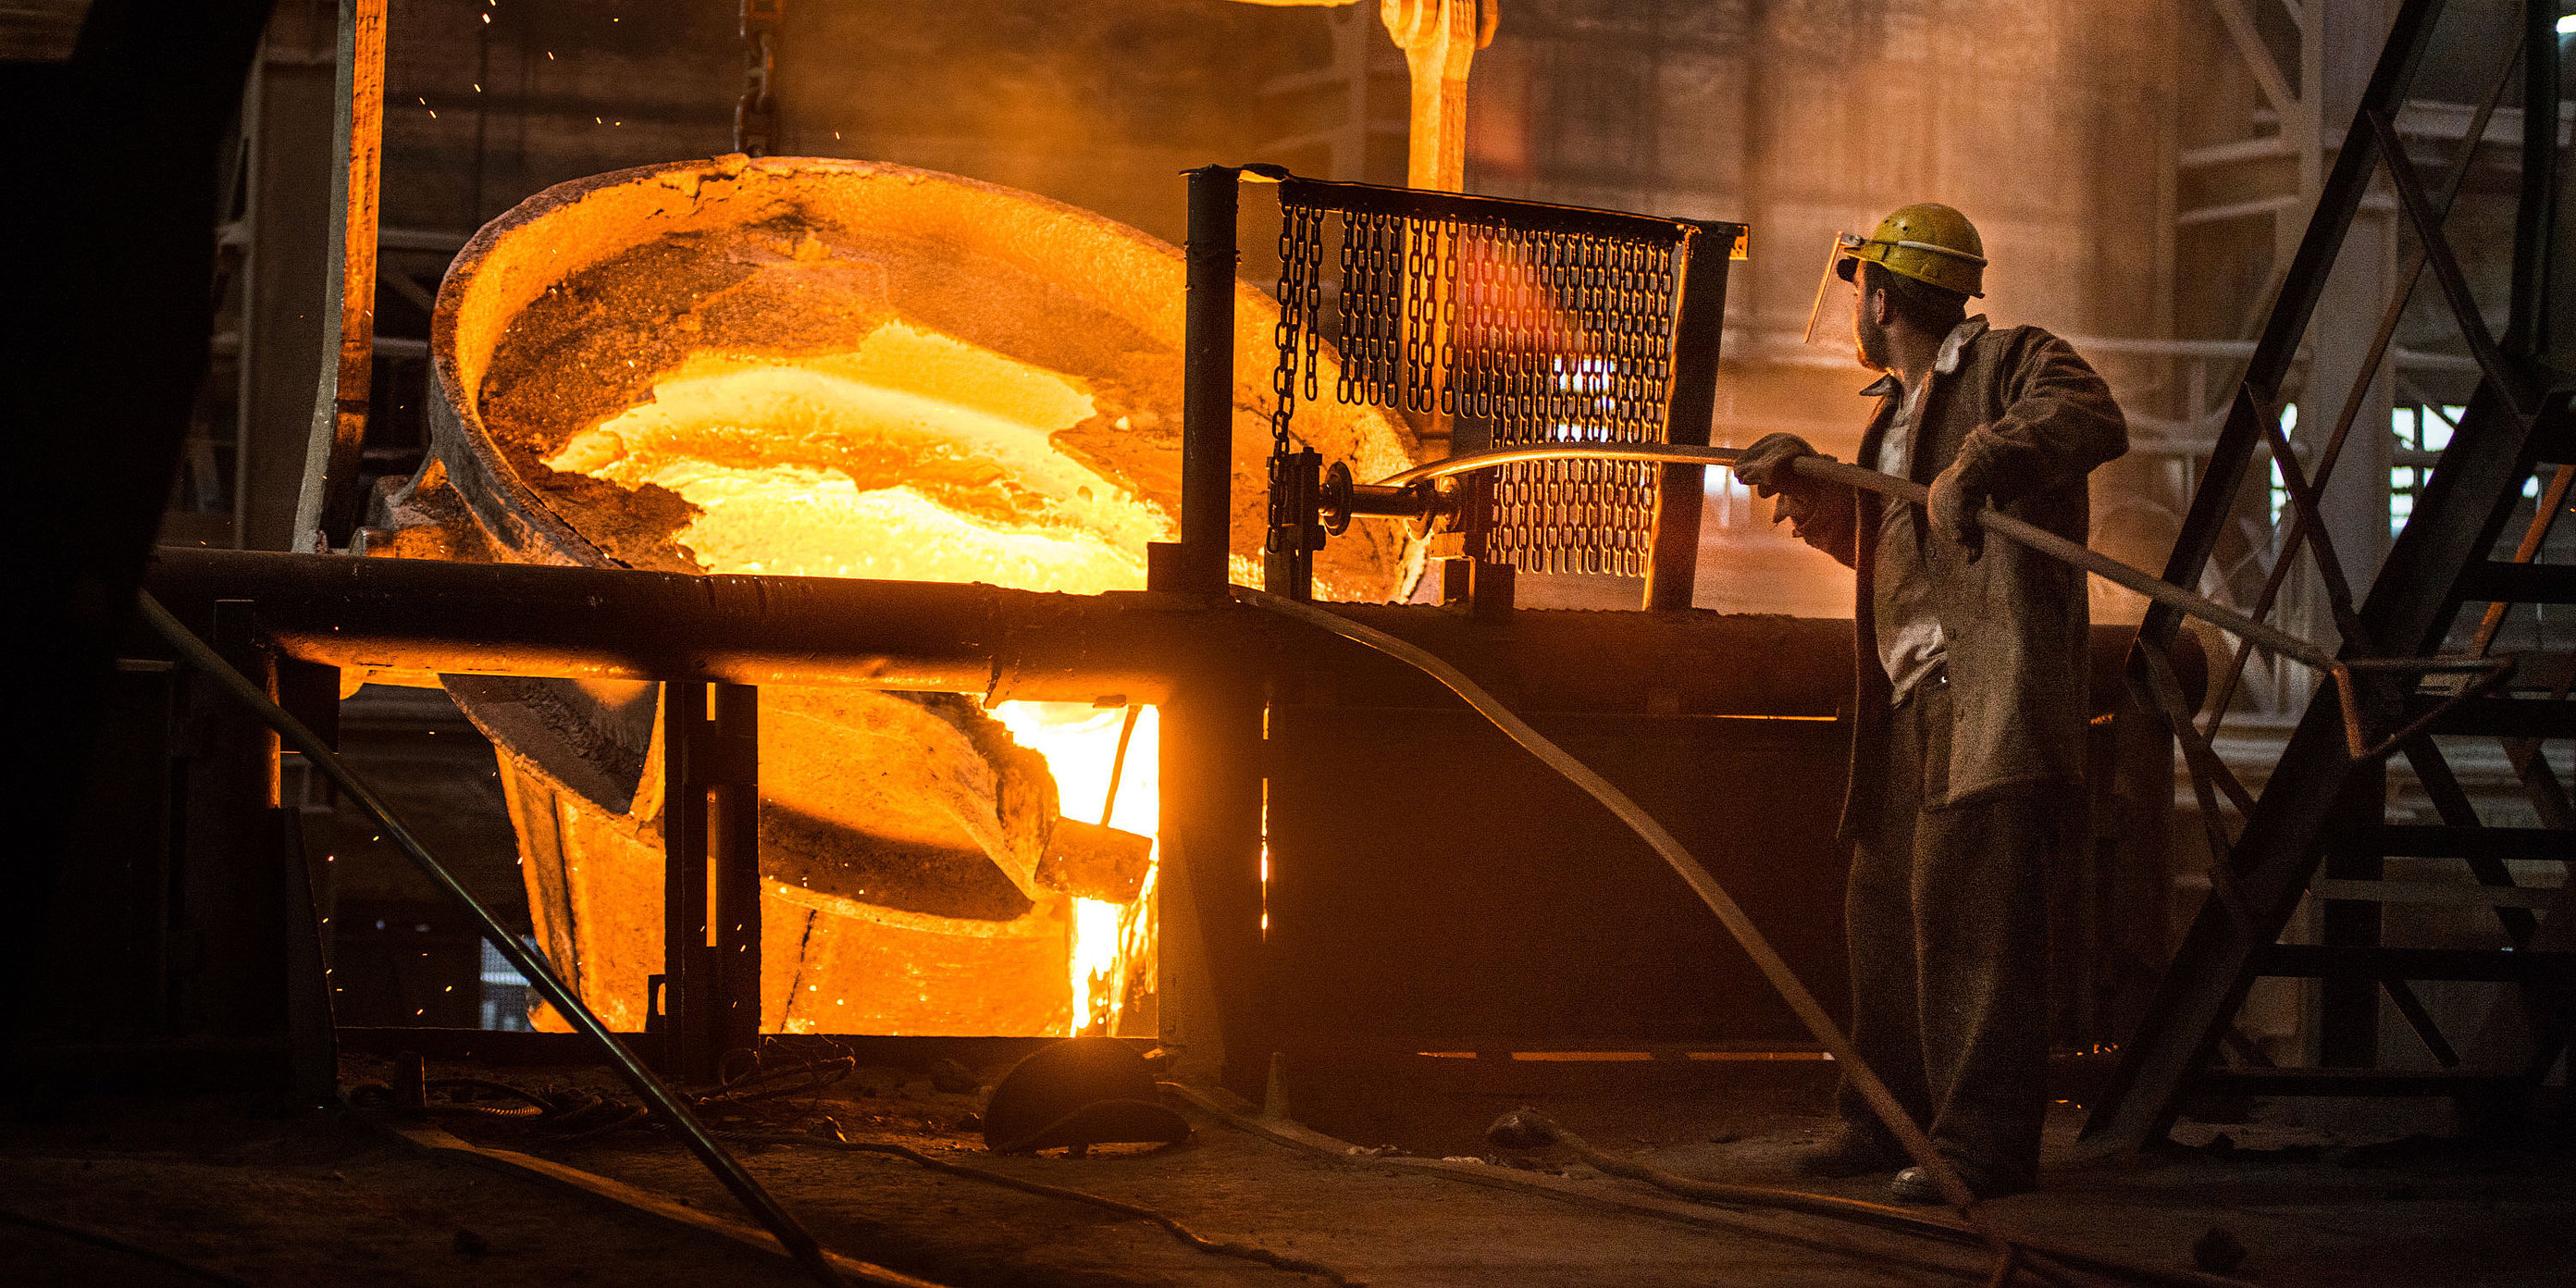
[422,157,1419,1033]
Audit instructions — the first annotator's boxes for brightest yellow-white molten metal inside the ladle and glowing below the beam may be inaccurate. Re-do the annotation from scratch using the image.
[546,322,1175,1033]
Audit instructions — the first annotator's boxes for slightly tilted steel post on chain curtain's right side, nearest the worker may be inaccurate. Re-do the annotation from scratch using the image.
[1646,224,1736,608]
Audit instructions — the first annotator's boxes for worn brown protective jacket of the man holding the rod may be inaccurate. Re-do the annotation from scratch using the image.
[1798,316,2128,837]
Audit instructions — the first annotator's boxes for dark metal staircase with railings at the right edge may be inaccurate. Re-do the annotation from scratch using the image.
[2084,0,2576,1146]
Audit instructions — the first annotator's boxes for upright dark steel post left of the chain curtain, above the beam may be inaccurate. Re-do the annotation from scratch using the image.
[1180,165,1242,595]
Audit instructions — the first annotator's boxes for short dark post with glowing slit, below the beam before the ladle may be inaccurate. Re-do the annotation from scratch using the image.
[662,683,760,1082]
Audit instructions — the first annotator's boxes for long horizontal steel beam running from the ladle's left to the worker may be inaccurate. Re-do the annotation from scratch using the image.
[144,549,1916,719]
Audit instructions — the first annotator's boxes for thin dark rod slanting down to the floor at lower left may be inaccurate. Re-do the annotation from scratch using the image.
[137,590,896,1288]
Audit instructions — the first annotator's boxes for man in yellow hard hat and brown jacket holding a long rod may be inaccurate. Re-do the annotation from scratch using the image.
[1734,204,2128,1203]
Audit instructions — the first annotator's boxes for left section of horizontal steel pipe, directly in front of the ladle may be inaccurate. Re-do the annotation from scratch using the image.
[144,549,1206,700]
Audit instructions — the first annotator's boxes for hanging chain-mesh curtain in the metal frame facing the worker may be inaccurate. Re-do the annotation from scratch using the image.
[1270,180,1734,577]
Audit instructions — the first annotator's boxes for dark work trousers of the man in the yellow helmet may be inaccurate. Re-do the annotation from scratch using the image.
[1839,677,2050,1187]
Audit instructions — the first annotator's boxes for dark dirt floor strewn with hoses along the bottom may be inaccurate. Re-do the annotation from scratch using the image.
[0,1059,2576,1288]
